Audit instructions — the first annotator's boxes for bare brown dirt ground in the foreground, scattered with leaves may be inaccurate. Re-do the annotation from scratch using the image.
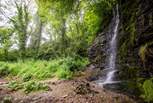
[0,65,136,103]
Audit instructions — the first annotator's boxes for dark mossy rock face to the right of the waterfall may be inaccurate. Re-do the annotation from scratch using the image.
[118,0,153,79]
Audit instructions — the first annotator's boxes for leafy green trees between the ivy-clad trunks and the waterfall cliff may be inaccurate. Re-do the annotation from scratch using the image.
[32,0,116,59]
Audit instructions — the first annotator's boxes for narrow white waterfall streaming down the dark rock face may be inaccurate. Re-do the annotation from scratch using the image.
[104,5,119,84]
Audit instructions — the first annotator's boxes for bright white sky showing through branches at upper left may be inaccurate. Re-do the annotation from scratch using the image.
[0,0,37,27]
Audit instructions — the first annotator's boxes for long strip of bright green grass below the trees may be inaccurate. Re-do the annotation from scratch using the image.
[0,57,88,79]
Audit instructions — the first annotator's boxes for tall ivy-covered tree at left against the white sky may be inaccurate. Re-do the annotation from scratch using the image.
[10,2,29,60]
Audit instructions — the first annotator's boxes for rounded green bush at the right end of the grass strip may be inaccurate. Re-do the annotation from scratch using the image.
[56,56,88,79]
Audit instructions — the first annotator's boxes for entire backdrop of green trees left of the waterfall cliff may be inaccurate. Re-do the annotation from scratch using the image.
[0,0,116,61]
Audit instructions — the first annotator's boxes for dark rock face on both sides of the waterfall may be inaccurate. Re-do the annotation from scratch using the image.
[89,0,153,93]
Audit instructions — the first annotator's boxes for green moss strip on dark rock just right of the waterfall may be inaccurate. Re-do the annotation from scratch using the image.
[119,1,138,58]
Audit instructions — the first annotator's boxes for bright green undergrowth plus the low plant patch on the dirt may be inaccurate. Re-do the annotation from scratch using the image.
[4,56,88,93]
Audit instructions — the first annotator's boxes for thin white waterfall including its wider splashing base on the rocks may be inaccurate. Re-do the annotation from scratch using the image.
[98,5,120,85]
